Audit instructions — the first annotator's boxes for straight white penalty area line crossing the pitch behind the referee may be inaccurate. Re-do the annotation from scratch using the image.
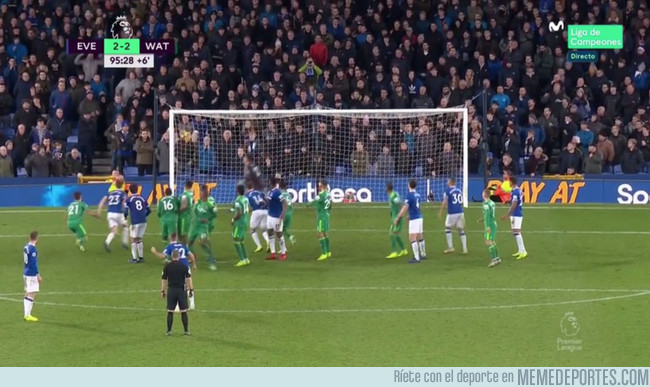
[0,286,650,297]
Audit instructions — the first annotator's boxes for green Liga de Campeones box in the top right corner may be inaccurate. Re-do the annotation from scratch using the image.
[567,24,623,50]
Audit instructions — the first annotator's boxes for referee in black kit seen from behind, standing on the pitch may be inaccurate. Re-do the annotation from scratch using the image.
[160,251,194,336]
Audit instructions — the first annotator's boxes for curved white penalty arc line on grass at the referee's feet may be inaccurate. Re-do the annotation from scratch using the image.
[0,291,650,314]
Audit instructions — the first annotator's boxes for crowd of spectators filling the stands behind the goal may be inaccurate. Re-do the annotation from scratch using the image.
[0,0,650,177]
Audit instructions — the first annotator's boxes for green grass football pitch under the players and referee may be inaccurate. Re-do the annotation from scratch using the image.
[0,203,650,367]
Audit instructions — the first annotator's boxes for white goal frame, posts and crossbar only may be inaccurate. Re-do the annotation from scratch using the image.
[168,107,469,208]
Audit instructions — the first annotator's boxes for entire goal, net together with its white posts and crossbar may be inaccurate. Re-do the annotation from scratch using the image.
[168,108,468,206]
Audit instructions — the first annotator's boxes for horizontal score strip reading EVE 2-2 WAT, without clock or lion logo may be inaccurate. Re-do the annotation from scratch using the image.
[66,39,176,56]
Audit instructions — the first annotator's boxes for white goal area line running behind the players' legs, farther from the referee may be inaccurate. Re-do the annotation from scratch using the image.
[0,228,650,238]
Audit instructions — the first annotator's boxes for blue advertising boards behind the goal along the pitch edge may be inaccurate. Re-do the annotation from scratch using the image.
[0,175,650,207]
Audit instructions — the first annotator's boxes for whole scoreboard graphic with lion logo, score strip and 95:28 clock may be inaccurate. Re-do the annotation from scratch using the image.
[66,16,176,68]
